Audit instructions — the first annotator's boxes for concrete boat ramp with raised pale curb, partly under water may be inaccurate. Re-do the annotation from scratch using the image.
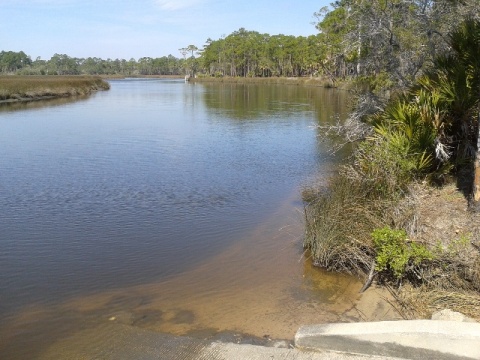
[42,320,480,360]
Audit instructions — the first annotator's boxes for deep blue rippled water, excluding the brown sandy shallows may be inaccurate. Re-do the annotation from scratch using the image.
[0,80,352,358]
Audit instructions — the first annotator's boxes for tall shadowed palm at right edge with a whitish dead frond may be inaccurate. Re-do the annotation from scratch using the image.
[411,19,480,204]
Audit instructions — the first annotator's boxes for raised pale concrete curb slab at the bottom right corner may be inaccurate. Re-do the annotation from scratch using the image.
[295,320,480,360]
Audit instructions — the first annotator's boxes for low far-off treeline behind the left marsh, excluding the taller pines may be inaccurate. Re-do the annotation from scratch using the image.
[0,51,185,76]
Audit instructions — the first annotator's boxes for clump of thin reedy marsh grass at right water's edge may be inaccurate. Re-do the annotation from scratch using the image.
[302,169,394,275]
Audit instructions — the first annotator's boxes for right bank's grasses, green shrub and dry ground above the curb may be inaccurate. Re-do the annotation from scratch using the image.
[303,121,480,320]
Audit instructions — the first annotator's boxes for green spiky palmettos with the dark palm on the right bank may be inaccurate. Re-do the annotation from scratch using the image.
[367,20,480,177]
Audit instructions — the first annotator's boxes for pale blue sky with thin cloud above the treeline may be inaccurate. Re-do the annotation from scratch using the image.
[0,0,331,60]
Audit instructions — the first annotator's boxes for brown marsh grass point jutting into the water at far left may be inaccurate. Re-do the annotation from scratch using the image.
[0,75,110,102]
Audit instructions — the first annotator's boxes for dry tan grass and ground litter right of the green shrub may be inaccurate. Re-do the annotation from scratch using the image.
[393,183,480,321]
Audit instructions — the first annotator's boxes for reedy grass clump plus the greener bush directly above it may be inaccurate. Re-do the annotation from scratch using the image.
[303,126,431,274]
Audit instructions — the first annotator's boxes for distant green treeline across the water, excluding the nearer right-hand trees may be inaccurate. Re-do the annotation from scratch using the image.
[0,28,322,77]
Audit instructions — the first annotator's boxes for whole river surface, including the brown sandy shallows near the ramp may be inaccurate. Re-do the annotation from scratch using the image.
[0,80,360,358]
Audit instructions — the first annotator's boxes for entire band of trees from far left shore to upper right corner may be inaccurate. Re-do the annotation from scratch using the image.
[0,0,480,84]
